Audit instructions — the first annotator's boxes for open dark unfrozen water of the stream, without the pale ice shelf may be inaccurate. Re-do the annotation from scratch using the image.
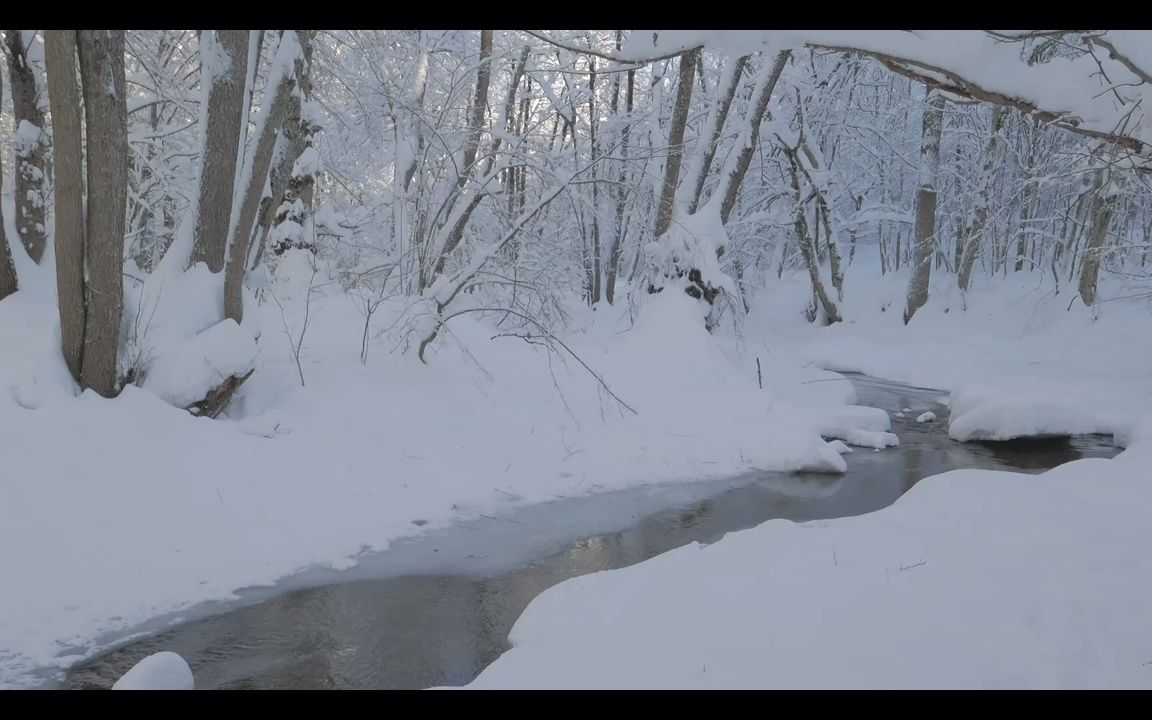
[67,377,1116,689]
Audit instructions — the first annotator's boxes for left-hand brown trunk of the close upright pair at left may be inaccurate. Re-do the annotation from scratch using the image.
[44,30,88,382]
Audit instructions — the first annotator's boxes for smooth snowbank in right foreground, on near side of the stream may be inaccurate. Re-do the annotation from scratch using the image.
[469,449,1152,689]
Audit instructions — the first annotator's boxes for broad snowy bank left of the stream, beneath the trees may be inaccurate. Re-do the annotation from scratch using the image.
[0,253,892,687]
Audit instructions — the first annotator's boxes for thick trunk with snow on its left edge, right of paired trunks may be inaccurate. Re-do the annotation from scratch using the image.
[191,30,249,273]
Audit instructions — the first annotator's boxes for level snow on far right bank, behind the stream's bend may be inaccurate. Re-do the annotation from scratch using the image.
[746,268,1152,440]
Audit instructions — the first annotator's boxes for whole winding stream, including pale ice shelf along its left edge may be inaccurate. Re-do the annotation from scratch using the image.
[65,376,1117,689]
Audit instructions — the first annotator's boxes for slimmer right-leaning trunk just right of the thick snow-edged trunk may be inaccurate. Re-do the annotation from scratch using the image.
[223,30,304,323]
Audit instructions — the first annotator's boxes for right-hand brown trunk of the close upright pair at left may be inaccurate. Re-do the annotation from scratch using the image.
[71,30,128,397]
